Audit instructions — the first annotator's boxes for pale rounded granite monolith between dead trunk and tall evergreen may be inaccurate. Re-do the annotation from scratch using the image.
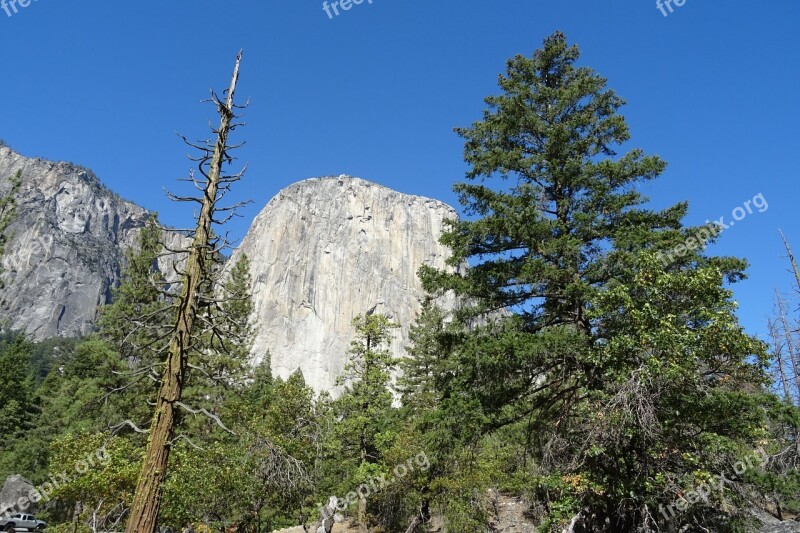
[234,176,456,391]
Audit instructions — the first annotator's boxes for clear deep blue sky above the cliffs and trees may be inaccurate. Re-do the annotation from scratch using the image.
[0,0,800,333]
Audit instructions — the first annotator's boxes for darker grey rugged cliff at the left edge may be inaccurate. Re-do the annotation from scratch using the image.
[0,147,183,339]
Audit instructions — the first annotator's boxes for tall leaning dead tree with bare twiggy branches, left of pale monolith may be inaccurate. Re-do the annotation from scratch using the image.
[126,52,244,533]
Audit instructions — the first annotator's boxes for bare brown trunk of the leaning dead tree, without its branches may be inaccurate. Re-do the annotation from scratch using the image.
[125,52,242,533]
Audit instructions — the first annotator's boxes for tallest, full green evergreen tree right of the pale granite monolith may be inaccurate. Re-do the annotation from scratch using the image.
[421,33,764,531]
